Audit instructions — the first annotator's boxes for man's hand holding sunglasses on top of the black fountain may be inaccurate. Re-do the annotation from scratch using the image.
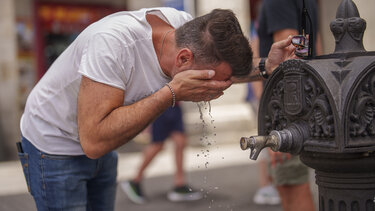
[266,36,298,75]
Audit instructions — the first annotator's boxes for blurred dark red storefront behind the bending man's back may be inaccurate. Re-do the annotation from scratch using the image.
[34,1,125,79]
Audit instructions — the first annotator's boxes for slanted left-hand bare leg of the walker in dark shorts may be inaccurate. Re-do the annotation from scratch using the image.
[133,142,164,183]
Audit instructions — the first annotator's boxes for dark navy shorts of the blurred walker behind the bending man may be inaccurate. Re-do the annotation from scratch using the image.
[152,106,184,143]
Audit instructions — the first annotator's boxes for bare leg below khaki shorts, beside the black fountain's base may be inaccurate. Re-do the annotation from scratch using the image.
[277,183,315,211]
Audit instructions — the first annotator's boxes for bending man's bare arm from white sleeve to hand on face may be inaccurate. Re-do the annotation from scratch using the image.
[78,70,231,158]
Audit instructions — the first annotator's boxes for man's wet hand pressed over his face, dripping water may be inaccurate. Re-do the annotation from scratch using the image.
[169,70,232,102]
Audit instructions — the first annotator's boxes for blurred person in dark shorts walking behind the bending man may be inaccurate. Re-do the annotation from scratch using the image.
[121,104,203,204]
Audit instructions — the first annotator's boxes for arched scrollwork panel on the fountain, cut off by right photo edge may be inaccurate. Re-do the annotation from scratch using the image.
[349,73,375,137]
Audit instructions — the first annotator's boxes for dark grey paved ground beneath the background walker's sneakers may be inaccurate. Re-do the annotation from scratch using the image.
[0,164,281,211]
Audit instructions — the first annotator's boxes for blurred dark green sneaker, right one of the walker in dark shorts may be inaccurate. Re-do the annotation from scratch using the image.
[167,185,203,201]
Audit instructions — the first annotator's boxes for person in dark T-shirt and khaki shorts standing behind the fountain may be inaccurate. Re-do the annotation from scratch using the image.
[258,0,321,211]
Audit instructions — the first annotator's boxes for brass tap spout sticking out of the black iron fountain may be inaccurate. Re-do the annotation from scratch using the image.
[240,135,280,160]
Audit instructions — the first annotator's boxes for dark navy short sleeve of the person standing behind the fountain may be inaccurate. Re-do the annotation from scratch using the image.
[265,0,299,34]
